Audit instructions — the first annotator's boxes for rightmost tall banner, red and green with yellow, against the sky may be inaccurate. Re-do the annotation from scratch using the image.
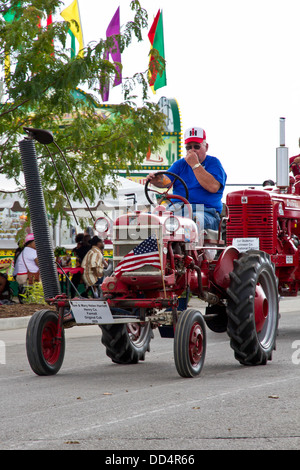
[148,10,167,94]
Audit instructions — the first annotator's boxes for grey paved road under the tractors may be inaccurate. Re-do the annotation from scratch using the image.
[0,299,300,456]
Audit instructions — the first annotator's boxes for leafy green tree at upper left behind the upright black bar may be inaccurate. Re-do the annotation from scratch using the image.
[0,0,164,228]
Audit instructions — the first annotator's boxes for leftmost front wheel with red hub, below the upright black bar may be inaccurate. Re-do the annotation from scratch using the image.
[26,310,65,375]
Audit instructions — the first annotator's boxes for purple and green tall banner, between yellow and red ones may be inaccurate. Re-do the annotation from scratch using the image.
[101,7,122,101]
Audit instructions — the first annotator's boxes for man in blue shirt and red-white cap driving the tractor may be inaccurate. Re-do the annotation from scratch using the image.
[147,127,227,230]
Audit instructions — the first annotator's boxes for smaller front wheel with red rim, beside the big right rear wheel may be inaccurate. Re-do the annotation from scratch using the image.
[174,308,206,377]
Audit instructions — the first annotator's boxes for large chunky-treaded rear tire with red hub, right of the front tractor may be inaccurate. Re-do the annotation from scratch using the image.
[227,250,279,365]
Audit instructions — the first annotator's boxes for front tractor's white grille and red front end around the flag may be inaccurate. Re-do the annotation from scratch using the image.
[102,206,202,298]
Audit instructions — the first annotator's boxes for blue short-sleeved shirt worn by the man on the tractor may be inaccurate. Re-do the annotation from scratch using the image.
[168,155,227,212]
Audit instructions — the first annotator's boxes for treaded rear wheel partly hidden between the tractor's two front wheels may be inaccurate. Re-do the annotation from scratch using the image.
[101,322,153,364]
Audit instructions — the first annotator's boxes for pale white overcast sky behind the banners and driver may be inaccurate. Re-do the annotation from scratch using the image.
[47,0,300,184]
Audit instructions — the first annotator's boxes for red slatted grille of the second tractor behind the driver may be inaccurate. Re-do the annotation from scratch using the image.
[226,204,275,254]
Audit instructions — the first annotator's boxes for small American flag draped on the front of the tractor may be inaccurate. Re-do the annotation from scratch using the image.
[115,236,161,277]
